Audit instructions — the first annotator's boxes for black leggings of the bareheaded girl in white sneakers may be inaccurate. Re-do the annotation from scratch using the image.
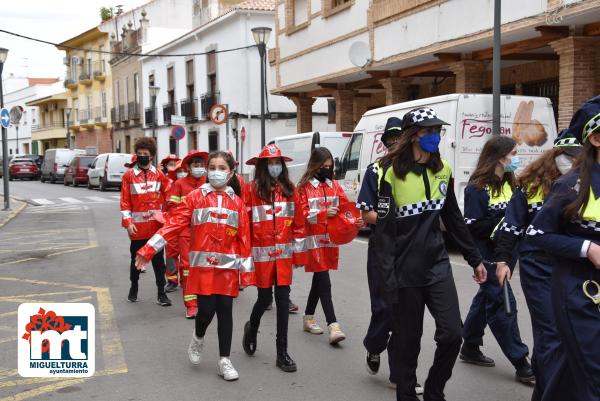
[196,294,233,358]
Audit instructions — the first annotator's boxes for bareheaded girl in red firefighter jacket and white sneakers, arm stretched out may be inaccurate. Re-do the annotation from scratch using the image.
[136,152,254,380]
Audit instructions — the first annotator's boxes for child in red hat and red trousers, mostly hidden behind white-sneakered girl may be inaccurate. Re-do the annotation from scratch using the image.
[167,150,208,319]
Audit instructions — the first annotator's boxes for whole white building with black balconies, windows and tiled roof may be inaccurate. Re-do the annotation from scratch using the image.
[141,0,333,172]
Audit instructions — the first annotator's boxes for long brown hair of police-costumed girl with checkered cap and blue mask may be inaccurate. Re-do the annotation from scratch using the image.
[381,126,444,180]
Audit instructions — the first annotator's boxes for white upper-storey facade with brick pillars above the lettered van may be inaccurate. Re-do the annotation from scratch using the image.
[269,0,600,131]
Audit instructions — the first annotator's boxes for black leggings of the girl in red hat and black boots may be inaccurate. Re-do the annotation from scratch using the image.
[250,285,290,345]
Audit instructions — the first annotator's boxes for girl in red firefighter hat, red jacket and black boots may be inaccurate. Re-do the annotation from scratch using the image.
[242,145,305,372]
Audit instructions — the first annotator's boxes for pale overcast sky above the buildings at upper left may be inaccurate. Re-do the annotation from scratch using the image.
[0,0,149,79]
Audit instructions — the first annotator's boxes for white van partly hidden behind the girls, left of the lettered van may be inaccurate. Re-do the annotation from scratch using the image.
[269,132,352,183]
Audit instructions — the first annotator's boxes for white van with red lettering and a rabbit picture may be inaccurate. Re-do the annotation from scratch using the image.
[336,94,557,209]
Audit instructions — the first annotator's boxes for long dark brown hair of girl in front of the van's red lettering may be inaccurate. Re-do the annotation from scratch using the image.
[469,135,517,196]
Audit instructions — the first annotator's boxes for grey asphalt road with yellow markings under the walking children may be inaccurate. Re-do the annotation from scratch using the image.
[0,182,532,401]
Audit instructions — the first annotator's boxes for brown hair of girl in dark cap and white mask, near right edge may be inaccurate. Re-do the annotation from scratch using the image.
[517,148,565,199]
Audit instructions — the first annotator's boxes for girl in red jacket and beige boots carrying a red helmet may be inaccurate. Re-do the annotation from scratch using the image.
[298,148,362,345]
